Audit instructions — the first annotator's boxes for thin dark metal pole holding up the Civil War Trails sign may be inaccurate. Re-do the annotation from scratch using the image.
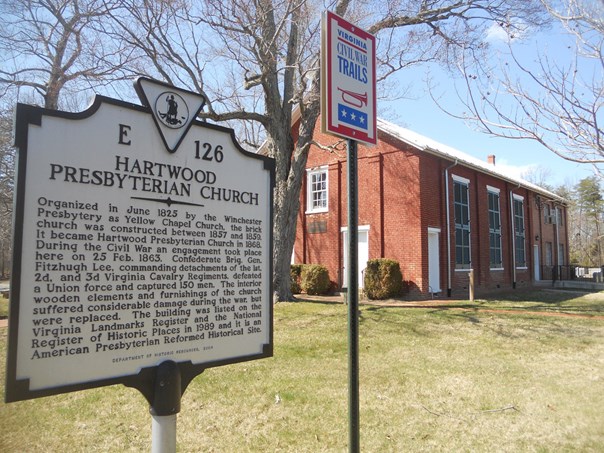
[347,140,360,453]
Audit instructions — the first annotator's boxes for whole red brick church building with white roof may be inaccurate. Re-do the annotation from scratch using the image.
[292,120,568,297]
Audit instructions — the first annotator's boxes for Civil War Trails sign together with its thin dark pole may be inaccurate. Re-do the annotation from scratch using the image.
[321,11,377,453]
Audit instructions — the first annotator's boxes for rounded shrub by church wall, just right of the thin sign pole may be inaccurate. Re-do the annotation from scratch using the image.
[364,258,403,300]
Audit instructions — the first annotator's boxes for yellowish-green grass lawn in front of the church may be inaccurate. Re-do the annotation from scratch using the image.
[0,291,604,453]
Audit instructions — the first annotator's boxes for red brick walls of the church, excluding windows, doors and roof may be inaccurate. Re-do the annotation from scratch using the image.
[294,117,568,297]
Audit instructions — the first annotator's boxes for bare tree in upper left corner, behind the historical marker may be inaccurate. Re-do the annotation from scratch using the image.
[0,0,130,110]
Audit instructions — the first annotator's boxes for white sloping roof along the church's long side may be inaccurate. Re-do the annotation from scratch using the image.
[377,118,567,204]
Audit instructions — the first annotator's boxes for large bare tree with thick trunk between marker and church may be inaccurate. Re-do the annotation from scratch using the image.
[106,0,543,300]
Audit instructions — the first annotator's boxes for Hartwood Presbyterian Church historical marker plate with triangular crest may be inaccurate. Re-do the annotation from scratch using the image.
[6,79,274,401]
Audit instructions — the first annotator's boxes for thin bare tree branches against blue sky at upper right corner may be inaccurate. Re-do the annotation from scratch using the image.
[444,0,604,171]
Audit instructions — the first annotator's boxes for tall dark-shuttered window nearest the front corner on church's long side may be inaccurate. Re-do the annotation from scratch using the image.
[453,176,472,269]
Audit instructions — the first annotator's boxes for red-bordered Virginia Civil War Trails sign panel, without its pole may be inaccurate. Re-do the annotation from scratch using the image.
[321,11,377,145]
